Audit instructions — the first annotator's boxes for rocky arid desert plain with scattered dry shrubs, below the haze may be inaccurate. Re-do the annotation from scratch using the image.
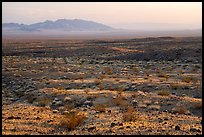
[2,37,202,135]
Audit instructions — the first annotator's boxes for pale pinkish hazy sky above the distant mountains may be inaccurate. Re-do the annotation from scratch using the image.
[2,2,202,29]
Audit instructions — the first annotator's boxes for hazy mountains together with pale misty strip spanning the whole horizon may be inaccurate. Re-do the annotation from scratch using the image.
[2,19,202,39]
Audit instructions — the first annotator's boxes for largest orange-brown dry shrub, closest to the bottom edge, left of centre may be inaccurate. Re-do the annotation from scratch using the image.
[60,111,87,130]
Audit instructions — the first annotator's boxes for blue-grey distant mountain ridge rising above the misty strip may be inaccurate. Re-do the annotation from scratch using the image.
[2,19,113,31]
